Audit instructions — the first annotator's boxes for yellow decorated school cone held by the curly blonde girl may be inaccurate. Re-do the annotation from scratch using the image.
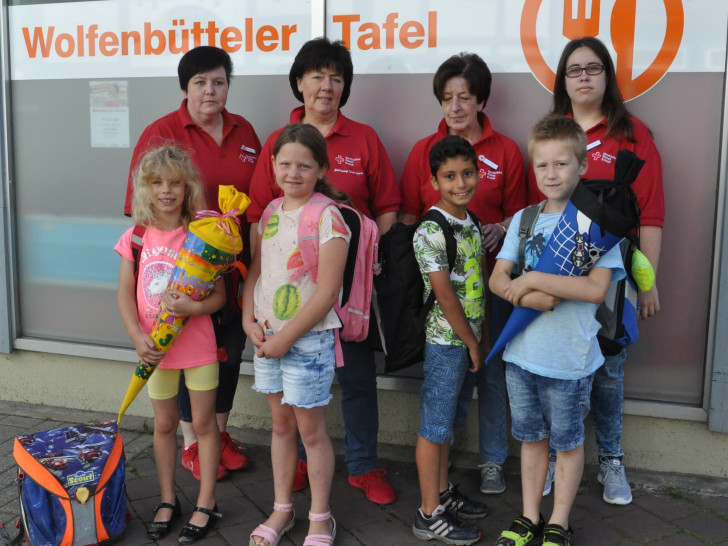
[116,186,250,423]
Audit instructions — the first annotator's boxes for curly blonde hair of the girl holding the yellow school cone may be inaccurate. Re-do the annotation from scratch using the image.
[131,144,205,229]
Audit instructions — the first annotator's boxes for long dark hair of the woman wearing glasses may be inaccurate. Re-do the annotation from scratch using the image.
[551,36,634,141]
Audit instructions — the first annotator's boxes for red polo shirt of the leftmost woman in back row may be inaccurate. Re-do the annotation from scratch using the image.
[124,99,260,216]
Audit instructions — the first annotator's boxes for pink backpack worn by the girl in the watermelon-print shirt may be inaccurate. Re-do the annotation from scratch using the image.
[260,193,379,366]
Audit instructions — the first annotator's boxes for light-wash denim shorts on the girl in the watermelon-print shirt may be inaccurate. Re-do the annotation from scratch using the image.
[253,330,336,408]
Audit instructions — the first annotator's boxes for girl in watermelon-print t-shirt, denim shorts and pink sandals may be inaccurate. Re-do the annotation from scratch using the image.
[243,124,351,546]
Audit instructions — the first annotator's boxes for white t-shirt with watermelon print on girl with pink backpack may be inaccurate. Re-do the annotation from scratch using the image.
[254,205,351,332]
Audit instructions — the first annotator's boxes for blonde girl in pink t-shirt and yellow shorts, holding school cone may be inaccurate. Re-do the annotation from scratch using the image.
[114,145,226,543]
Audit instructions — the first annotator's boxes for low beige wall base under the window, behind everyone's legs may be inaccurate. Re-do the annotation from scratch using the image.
[0,351,728,477]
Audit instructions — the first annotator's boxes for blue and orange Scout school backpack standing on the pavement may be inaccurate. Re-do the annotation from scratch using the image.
[13,421,127,546]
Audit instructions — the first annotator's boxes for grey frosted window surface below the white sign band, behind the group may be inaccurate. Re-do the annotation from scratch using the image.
[12,69,723,405]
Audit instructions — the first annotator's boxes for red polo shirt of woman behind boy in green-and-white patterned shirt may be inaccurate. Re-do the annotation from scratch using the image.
[400,113,526,224]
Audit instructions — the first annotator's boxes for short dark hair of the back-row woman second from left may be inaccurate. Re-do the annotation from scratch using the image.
[288,36,354,107]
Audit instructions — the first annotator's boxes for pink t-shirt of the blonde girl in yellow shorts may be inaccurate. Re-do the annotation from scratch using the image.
[114,223,217,369]
